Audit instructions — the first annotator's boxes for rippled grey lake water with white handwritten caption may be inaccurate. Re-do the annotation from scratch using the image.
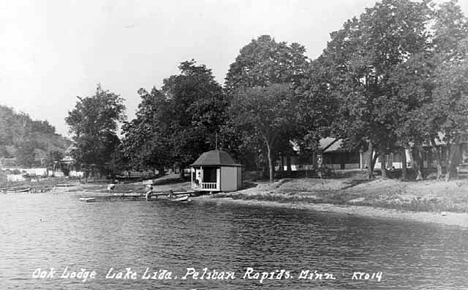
[0,194,468,290]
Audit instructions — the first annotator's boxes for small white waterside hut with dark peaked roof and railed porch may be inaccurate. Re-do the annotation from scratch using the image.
[190,150,242,192]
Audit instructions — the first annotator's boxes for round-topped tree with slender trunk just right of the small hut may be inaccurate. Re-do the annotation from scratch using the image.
[224,35,309,179]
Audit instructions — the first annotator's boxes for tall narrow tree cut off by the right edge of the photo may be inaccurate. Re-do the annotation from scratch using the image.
[431,0,468,181]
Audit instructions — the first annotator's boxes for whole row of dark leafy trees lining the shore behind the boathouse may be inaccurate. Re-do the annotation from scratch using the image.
[67,0,468,180]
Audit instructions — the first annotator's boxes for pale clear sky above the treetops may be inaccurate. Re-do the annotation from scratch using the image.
[0,0,468,136]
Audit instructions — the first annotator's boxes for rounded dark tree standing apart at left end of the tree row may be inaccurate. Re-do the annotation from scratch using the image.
[65,85,125,174]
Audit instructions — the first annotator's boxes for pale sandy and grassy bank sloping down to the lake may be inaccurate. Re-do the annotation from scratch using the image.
[6,172,468,228]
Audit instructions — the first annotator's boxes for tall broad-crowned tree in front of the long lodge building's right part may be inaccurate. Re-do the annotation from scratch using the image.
[321,0,430,179]
